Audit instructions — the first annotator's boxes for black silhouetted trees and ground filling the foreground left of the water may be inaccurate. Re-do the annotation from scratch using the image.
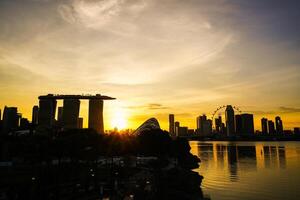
[0,129,203,200]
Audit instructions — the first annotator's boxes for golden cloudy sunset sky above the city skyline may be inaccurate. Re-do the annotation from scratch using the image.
[0,0,300,129]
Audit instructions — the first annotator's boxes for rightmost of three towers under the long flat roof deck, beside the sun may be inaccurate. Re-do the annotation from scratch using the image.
[88,99,104,133]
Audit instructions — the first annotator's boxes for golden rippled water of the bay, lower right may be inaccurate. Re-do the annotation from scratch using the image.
[191,142,300,200]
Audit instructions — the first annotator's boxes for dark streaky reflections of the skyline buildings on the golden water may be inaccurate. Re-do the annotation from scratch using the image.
[197,143,286,181]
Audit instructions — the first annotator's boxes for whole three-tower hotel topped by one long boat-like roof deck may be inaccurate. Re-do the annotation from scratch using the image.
[37,94,115,133]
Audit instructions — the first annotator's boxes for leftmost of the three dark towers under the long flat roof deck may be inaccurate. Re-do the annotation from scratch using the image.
[38,99,56,127]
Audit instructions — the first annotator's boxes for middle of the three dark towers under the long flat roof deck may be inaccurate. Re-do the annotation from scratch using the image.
[62,99,80,129]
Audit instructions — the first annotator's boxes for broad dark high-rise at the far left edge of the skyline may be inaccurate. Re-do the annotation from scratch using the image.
[2,106,19,134]
